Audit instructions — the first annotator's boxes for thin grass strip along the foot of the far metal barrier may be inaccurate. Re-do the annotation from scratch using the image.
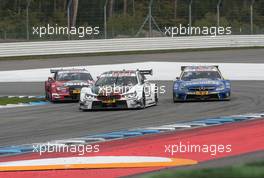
[0,47,264,60]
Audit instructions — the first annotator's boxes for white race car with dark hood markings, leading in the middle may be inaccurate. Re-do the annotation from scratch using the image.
[80,70,158,110]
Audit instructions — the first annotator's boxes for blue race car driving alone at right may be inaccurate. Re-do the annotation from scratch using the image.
[173,66,231,102]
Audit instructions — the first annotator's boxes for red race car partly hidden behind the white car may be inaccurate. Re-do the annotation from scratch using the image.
[45,69,94,102]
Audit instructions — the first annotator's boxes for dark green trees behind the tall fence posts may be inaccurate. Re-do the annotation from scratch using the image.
[0,0,264,39]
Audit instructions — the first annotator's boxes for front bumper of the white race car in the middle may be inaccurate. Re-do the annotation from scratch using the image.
[80,99,141,110]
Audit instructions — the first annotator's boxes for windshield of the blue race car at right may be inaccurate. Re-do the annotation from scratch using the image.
[181,71,222,80]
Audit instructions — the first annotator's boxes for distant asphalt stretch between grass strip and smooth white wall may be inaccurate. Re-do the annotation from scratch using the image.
[0,48,264,71]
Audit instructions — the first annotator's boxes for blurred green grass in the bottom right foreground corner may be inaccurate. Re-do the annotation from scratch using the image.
[141,161,264,178]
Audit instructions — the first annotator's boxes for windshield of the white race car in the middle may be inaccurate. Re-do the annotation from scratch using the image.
[95,76,138,86]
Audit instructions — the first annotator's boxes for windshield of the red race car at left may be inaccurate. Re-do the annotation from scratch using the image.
[55,73,93,81]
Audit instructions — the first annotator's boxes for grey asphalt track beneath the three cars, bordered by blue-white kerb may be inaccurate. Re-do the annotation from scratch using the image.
[0,81,264,145]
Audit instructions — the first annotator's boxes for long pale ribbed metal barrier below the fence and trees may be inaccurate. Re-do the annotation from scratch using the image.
[0,35,264,57]
